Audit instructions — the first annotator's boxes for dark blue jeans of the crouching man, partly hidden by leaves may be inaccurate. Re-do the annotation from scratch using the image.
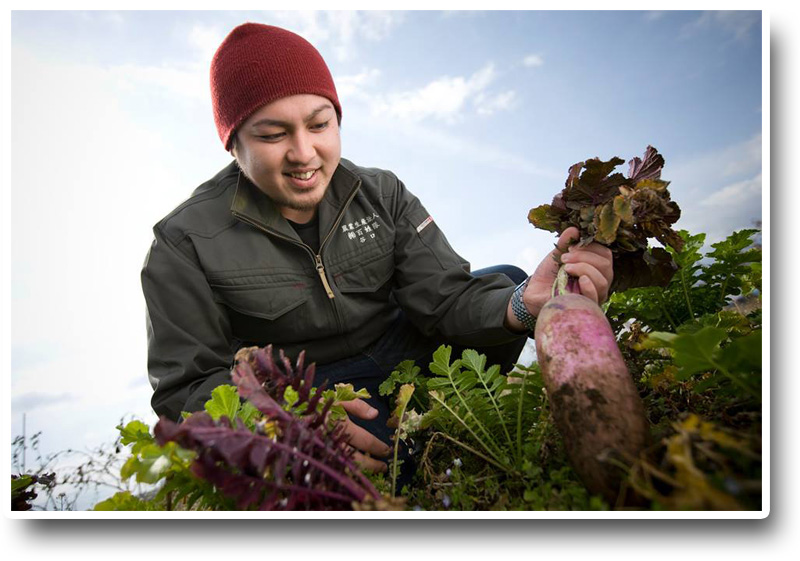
[314,265,528,487]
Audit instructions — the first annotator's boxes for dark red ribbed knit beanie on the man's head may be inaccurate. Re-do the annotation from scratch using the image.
[211,23,342,150]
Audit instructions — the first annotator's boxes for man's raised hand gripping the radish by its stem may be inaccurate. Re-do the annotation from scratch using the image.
[506,226,614,331]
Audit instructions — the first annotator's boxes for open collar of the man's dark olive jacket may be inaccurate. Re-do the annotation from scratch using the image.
[231,160,360,239]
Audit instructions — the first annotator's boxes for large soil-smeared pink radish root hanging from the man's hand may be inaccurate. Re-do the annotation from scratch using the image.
[534,284,648,505]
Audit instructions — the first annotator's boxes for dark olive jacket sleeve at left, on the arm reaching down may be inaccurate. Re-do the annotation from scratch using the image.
[142,226,235,420]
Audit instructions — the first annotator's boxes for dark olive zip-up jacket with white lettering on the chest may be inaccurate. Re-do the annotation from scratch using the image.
[142,159,519,419]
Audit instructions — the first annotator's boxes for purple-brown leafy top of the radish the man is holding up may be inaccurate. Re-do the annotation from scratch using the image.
[528,146,683,292]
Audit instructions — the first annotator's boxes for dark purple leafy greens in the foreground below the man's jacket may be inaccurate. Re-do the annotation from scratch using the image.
[155,345,385,510]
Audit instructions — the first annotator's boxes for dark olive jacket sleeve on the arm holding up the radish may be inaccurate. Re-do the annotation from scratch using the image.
[394,181,520,345]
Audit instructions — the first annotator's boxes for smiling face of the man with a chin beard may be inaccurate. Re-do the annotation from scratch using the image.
[234,94,342,224]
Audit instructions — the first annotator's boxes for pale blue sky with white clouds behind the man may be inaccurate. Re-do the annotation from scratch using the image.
[10,11,763,508]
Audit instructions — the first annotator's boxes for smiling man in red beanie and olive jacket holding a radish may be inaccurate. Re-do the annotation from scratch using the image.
[142,23,611,470]
